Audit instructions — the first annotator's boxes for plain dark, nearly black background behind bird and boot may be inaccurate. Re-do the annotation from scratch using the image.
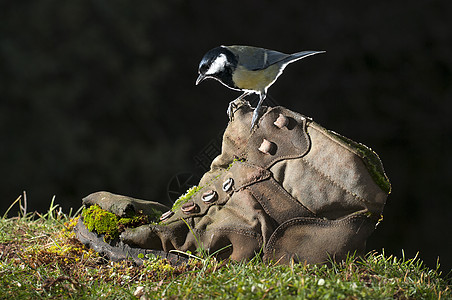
[0,0,452,272]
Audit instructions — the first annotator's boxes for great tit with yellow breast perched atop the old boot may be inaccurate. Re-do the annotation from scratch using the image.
[196,46,325,130]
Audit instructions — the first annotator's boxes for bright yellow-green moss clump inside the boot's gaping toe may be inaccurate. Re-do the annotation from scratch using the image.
[82,205,155,241]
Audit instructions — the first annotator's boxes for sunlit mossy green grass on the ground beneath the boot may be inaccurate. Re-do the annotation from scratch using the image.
[0,197,452,300]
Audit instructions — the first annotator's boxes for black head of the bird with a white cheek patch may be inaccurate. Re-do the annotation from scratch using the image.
[196,46,237,86]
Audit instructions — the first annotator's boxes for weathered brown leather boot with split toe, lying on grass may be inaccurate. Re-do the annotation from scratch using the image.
[76,105,390,263]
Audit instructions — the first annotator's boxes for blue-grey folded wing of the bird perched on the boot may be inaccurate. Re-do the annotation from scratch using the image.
[225,46,290,71]
